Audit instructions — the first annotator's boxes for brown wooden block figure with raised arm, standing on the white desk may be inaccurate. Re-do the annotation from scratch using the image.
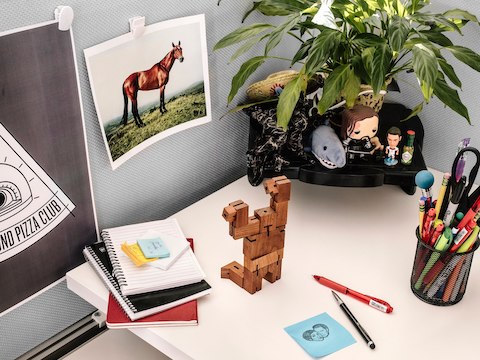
[221,176,291,294]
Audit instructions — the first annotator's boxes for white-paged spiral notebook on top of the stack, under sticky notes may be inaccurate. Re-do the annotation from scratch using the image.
[101,219,205,295]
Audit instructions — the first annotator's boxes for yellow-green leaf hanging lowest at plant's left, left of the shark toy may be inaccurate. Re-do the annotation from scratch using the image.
[277,73,307,130]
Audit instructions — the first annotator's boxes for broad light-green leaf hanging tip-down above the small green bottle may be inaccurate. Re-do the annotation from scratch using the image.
[412,44,438,102]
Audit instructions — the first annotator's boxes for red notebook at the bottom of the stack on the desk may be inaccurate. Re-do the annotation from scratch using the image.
[107,293,198,329]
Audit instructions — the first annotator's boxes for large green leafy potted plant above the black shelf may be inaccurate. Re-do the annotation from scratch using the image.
[215,0,480,128]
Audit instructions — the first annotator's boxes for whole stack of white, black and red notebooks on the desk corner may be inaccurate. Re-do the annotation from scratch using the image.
[83,219,211,328]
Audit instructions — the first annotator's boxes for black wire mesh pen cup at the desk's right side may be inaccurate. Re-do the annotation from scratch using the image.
[410,227,479,306]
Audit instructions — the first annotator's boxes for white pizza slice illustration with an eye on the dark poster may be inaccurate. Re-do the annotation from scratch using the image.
[0,124,75,262]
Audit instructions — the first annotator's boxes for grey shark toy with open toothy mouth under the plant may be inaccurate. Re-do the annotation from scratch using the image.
[311,125,346,169]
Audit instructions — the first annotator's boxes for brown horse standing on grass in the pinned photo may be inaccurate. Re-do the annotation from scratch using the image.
[122,41,183,127]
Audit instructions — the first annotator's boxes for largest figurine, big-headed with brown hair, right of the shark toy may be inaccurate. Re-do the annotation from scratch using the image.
[340,105,383,159]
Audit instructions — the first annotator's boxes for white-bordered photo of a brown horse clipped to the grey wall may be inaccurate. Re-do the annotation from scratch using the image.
[84,15,211,169]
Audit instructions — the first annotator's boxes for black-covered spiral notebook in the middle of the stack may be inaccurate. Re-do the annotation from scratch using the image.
[83,242,211,320]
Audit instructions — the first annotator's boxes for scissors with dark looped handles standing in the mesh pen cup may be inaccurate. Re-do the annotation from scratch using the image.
[450,146,480,214]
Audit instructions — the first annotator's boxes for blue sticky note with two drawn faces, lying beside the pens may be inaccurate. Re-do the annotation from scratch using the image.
[284,313,356,357]
